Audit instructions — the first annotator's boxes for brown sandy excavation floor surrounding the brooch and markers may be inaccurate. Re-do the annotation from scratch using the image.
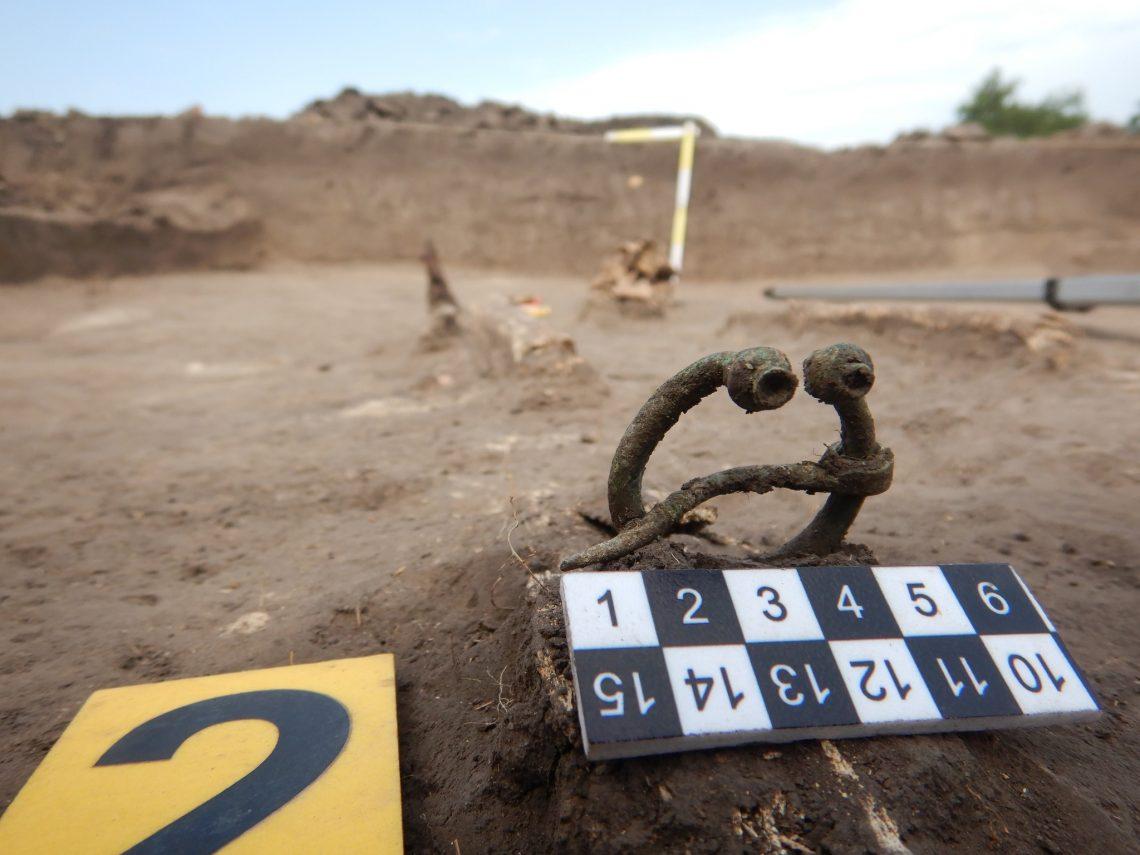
[0,266,1140,853]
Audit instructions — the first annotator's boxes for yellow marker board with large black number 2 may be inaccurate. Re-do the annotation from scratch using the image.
[0,653,402,855]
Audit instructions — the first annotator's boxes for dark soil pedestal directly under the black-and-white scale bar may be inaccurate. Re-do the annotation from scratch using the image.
[469,547,1129,853]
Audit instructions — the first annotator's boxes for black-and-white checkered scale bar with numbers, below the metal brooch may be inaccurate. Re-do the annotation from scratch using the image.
[562,564,1099,759]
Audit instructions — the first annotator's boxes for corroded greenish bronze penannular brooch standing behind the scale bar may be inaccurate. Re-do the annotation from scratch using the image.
[562,344,894,570]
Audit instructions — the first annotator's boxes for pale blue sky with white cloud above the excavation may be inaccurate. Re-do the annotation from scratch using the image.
[0,0,1140,146]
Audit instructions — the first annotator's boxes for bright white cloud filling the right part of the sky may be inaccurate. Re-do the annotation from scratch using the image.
[513,0,1140,146]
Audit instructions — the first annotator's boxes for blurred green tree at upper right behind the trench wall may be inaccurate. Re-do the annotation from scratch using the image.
[958,68,1089,137]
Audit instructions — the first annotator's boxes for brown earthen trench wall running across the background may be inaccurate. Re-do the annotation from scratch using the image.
[0,103,1140,282]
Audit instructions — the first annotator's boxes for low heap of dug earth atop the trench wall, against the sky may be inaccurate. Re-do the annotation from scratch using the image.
[293,87,716,137]
